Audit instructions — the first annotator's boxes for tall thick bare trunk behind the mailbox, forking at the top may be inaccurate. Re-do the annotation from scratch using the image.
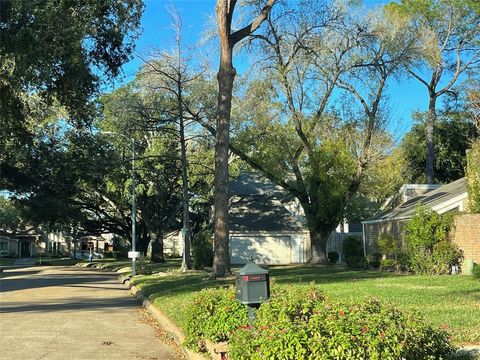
[213,0,276,276]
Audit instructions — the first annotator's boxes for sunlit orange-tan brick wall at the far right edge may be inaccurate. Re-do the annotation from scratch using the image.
[453,214,480,268]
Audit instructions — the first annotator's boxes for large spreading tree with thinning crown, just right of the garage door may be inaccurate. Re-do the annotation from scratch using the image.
[227,1,412,263]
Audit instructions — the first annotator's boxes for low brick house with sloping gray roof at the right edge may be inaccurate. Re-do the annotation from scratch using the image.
[362,178,480,270]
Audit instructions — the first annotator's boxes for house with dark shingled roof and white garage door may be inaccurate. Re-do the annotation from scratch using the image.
[229,173,360,265]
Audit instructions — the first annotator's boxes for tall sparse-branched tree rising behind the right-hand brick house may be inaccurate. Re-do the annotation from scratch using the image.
[387,0,480,184]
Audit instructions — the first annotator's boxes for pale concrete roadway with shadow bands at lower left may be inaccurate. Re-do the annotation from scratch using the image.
[0,267,181,360]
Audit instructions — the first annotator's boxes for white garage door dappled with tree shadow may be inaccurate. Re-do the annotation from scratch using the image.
[230,236,291,265]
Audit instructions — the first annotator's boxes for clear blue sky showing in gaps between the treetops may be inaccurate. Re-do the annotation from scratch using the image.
[117,0,428,140]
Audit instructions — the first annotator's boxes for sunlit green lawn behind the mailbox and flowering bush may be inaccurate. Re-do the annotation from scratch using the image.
[134,263,480,344]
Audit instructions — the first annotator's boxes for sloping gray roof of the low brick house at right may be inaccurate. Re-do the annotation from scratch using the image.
[363,177,467,223]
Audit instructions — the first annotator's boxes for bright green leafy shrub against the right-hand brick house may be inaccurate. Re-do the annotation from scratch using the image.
[405,207,463,275]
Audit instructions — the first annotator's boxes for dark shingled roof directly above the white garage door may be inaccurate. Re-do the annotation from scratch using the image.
[228,195,304,232]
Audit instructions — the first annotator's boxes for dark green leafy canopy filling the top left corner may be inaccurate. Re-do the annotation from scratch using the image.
[0,0,143,121]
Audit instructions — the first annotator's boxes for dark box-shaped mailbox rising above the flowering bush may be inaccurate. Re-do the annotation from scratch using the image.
[235,263,270,305]
